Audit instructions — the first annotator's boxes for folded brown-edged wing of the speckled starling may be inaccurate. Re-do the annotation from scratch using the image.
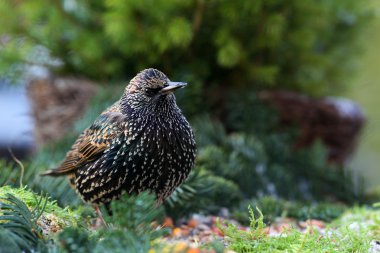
[42,112,125,176]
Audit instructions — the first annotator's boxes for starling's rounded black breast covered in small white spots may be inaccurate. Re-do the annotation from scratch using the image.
[119,113,196,198]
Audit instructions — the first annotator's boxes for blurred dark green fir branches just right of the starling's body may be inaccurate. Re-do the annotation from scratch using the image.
[194,114,356,204]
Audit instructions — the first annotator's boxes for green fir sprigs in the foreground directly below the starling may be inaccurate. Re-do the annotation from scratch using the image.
[56,193,166,252]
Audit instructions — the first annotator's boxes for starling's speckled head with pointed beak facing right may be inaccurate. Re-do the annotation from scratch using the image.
[124,68,186,102]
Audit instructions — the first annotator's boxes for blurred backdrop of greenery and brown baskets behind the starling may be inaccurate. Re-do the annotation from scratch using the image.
[0,0,380,216]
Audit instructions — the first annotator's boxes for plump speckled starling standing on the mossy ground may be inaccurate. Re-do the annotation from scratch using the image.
[42,68,196,205]
